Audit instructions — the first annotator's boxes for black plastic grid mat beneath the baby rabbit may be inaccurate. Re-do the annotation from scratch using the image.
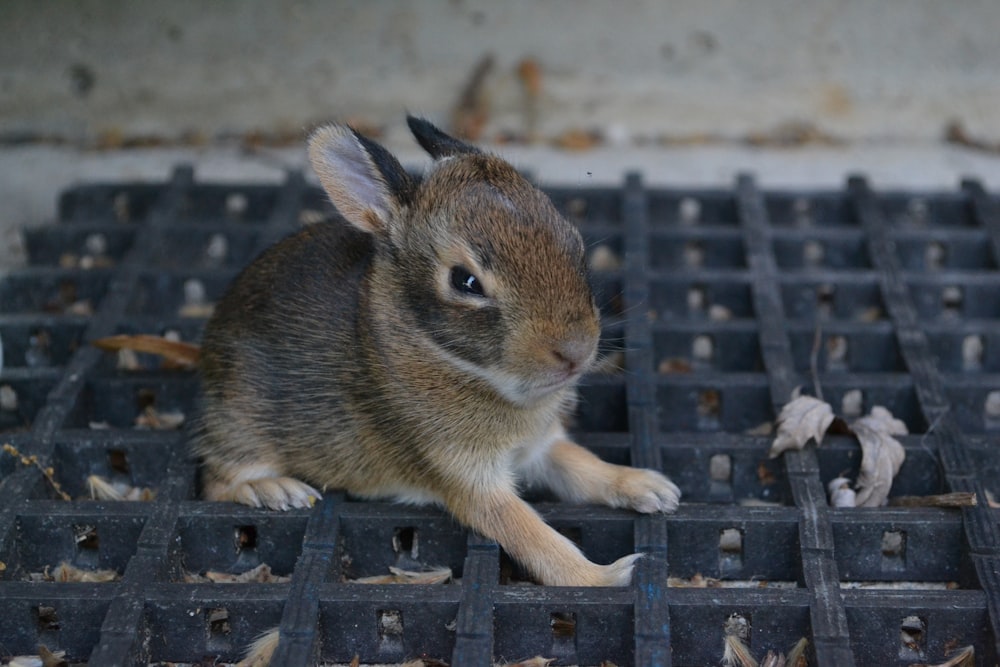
[0,168,1000,665]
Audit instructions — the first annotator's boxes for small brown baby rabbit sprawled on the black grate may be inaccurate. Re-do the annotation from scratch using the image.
[195,117,679,586]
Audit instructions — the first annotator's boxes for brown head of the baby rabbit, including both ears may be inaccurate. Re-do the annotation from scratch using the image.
[309,117,600,405]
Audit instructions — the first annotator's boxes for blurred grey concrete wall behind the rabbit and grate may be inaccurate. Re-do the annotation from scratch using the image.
[0,0,1000,145]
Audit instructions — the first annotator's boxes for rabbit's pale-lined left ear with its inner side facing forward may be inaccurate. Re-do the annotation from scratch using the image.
[309,125,415,237]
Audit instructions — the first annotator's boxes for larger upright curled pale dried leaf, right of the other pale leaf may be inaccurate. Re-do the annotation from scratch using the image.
[851,405,909,507]
